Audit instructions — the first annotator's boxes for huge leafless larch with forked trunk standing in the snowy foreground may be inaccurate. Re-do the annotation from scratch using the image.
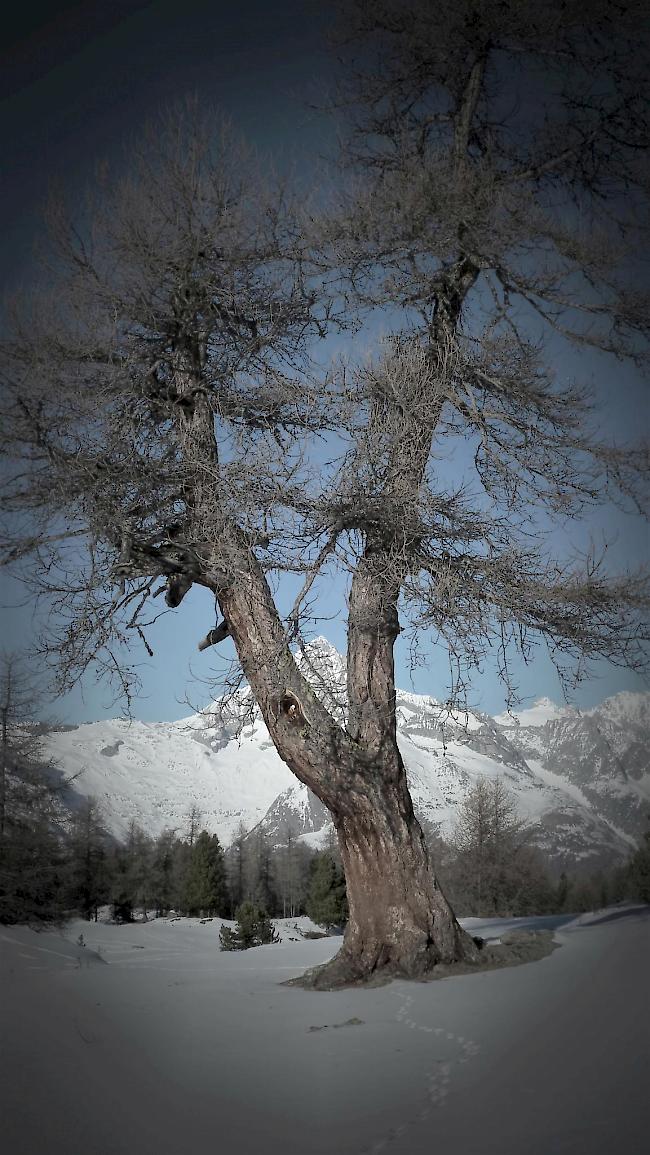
[3,0,649,986]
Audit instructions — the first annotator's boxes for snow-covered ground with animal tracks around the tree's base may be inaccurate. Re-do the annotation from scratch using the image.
[0,907,650,1155]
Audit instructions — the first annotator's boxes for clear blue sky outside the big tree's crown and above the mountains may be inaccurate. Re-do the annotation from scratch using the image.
[0,0,650,722]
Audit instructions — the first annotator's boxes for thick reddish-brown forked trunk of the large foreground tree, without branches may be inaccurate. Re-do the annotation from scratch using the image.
[167,328,477,988]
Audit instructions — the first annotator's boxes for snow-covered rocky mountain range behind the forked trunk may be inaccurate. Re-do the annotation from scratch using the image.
[47,639,650,870]
